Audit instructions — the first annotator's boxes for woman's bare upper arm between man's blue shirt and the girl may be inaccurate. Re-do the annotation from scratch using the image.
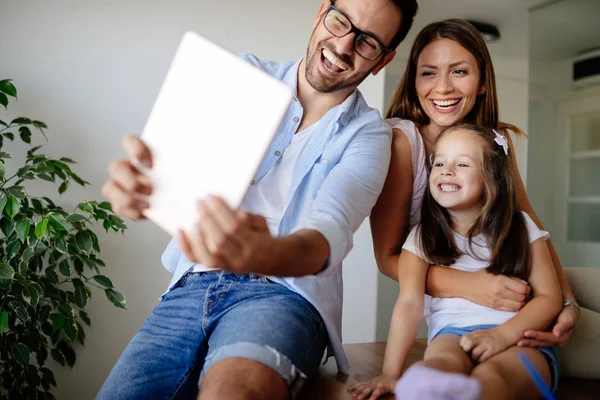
[369,129,413,281]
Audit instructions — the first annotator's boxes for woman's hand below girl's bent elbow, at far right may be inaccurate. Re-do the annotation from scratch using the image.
[517,307,580,347]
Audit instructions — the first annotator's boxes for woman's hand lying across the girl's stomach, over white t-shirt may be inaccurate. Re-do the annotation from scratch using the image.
[469,270,531,312]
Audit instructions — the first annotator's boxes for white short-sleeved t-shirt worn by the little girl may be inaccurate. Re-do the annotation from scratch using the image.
[402,213,549,341]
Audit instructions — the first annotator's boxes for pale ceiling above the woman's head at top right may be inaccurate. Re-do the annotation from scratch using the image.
[390,0,600,65]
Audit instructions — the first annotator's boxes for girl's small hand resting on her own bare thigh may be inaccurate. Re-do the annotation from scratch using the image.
[460,328,515,363]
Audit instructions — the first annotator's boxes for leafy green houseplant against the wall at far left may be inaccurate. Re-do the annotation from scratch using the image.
[0,79,126,399]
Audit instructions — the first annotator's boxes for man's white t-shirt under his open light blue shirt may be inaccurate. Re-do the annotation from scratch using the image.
[193,122,319,272]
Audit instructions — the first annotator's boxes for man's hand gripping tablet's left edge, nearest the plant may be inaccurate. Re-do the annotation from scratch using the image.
[102,135,152,220]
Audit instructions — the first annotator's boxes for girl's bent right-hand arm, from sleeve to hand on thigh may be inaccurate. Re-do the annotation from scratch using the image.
[460,238,562,362]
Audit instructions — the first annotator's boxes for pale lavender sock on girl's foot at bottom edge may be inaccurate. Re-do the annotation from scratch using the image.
[395,365,482,400]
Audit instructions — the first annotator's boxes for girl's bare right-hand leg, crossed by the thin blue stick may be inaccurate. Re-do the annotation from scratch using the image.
[471,346,551,400]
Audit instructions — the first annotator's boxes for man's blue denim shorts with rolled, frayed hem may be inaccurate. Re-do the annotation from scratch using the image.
[97,271,328,400]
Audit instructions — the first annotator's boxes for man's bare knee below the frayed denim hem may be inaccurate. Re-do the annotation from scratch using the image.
[198,358,288,400]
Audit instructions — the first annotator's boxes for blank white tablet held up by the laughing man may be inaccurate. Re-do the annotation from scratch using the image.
[141,32,293,236]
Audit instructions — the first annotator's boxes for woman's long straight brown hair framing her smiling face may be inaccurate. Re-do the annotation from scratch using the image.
[386,18,524,139]
